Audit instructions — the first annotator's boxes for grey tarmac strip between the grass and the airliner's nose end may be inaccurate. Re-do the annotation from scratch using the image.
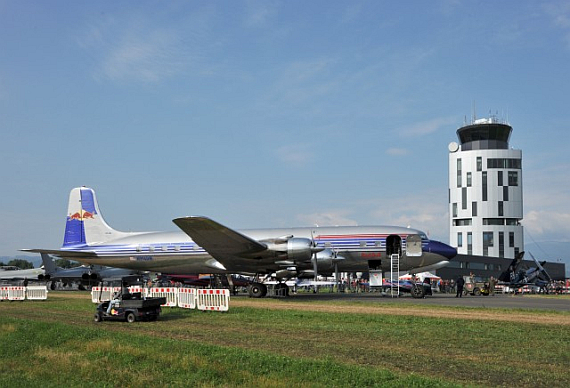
[266,292,570,311]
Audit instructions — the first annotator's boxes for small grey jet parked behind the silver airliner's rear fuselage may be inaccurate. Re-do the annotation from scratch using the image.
[41,253,140,289]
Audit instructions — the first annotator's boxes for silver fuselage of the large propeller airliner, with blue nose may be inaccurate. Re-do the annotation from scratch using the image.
[62,226,452,274]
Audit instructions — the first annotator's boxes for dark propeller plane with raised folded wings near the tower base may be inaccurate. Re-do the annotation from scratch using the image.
[498,251,552,290]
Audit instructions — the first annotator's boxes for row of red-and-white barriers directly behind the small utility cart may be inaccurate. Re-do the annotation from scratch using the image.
[91,286,230,311]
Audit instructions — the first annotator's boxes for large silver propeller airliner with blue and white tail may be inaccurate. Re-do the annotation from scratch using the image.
[22,187,457,297]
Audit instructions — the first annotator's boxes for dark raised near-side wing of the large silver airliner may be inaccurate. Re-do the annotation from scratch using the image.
[172,216,268,262]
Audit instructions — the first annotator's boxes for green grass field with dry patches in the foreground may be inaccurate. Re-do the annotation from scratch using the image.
[0,292,570,387]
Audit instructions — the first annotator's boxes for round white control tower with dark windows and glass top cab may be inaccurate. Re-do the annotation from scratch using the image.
[449,116,524,258]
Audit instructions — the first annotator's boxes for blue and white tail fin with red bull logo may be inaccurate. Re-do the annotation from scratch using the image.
[63,187,127,247]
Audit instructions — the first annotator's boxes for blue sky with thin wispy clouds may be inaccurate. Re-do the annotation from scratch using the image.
[0,0,570,272]
